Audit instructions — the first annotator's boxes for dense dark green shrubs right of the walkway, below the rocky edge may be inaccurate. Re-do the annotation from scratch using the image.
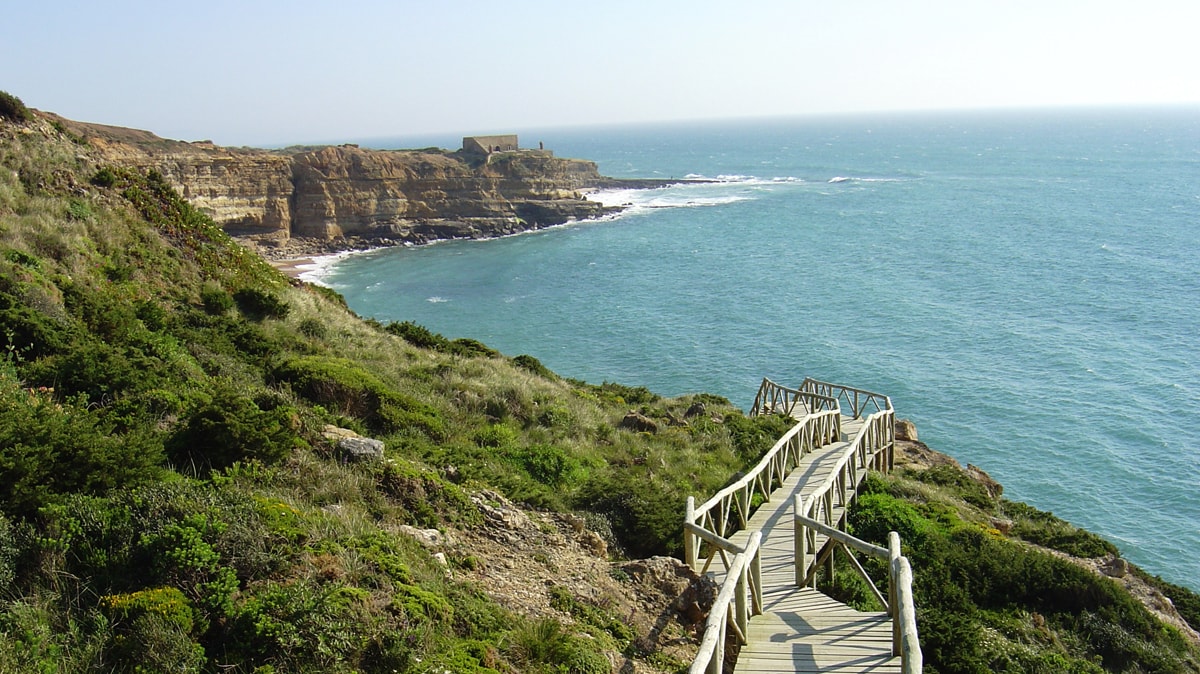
[850,474,1187,674]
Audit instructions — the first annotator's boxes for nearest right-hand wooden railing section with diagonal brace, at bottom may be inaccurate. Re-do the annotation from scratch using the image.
[796,510,924,674]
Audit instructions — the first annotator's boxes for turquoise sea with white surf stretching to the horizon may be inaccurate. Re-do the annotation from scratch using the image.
[317,109,1200,590]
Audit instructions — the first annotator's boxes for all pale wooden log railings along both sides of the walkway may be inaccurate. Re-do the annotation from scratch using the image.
[684,379,907,674]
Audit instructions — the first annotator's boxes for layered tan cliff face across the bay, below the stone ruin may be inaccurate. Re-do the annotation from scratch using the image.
[61,113,610,243]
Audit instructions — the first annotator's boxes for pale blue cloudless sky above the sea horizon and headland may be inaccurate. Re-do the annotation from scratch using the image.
[0,0,1200,145]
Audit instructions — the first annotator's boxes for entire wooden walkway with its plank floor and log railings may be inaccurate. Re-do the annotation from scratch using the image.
[684,379,922,674]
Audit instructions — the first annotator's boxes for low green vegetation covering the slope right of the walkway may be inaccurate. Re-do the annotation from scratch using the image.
[836,465,1200,674]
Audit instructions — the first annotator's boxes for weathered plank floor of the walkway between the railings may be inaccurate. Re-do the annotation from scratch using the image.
[696,417,901,674]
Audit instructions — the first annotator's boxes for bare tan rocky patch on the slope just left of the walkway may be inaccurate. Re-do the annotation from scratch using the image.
[404,491,718,674]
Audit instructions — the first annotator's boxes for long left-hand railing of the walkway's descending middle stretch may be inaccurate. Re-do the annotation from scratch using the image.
[683,409,841,573]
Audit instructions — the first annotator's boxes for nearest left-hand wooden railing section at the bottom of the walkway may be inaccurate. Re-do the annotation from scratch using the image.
[689,531,762,674]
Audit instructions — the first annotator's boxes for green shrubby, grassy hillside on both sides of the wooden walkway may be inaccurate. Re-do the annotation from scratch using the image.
[0,97,1196,673]
